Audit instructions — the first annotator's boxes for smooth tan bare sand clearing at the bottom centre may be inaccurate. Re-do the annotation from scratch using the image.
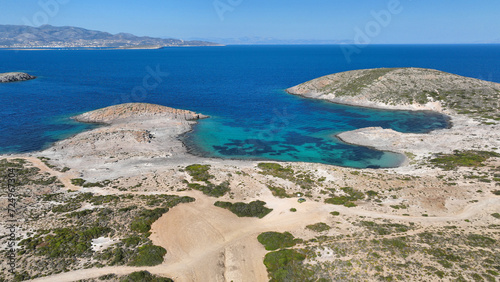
[150,188,328,281]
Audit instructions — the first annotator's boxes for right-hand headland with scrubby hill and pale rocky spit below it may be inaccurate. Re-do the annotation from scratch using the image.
[287,68,500,173]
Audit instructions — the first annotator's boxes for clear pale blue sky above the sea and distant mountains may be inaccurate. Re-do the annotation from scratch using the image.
[0,0,500,44]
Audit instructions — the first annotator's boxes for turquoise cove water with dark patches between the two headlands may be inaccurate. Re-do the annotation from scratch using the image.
[184,92,447,168]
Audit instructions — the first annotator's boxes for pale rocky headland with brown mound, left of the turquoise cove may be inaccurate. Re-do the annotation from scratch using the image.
[41,103,207,179]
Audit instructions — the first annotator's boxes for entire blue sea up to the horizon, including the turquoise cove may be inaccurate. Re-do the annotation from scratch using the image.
[0,45,500,167]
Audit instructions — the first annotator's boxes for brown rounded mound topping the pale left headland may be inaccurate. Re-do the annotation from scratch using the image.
[73,103,207,124]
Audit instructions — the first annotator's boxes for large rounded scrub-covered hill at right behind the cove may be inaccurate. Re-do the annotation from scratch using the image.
[287,68,500,117]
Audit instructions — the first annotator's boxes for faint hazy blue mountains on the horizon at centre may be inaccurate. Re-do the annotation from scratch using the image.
[182,36,354,45]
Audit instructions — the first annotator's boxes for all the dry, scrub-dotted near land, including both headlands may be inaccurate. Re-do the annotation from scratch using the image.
[0,69,500,281]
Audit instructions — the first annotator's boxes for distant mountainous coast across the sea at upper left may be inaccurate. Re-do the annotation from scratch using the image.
[0,25,220,48]
